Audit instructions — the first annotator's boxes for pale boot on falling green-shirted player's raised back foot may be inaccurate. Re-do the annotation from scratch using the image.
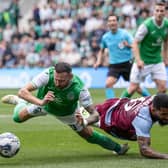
[1,95,19,105]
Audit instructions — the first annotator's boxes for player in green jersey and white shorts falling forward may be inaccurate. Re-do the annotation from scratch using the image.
[2,62,128,155]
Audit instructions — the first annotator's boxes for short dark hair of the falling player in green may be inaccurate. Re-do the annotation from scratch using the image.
[54,62,72,73]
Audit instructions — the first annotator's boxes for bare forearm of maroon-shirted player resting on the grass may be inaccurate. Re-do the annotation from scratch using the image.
[137,137,168,159]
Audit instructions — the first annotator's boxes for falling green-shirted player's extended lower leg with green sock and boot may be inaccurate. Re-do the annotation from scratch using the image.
[77,126,129,155]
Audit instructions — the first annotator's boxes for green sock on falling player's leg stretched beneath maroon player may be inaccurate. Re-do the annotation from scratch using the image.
[87,130,121,152]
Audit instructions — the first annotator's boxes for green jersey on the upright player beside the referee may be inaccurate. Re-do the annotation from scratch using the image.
[139,17,168,64]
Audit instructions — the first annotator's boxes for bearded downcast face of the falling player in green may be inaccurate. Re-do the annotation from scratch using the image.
[54,72,72,89]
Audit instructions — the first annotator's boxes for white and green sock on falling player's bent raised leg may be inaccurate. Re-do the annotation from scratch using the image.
[13,103,27,123]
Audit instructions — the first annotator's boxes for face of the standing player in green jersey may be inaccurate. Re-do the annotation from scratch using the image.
[154,5,166,23]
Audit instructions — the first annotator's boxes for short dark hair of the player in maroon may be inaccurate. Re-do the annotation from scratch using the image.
[153,93,168,110]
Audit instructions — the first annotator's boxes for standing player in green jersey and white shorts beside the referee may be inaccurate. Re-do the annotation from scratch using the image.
[121,2,168,97]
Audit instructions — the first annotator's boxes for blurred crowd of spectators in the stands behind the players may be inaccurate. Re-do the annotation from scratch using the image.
[0,0,166,68]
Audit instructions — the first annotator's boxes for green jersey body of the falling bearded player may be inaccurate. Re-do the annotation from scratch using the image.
[37,68,84,116]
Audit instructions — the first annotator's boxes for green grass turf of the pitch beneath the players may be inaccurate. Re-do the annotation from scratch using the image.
[0,89,168,168]
